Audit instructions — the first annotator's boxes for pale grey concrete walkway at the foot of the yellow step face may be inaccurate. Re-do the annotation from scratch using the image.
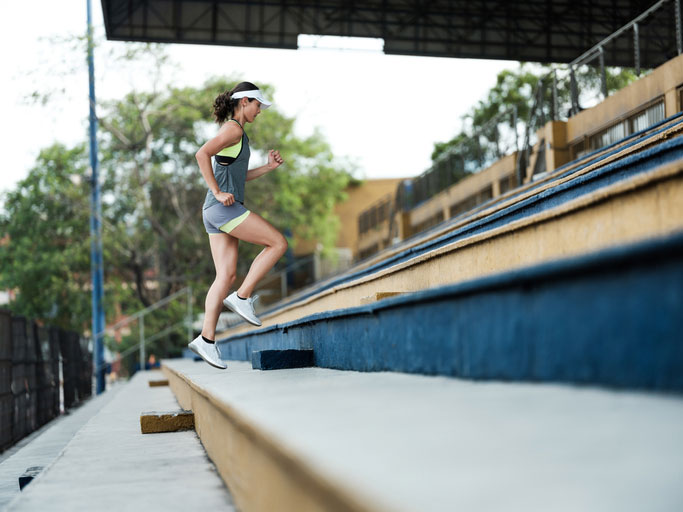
[7,371,235,512]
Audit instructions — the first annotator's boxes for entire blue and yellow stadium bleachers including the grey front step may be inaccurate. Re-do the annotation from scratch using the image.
[163,54,683,510]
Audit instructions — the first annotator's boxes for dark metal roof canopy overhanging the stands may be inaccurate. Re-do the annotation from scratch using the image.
[102,0,676,67]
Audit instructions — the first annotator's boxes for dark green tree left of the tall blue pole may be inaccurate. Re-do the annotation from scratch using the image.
[0,144,90,330]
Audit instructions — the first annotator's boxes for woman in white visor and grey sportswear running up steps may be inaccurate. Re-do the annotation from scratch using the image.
[188,82,287,369]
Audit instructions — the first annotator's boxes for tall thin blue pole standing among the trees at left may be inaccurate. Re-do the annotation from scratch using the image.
[87,0,104,395]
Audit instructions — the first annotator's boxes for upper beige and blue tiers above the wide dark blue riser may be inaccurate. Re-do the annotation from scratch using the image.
[218,119,683,339]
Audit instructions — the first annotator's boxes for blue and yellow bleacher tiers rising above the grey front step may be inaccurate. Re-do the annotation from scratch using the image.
[212,115,683,389]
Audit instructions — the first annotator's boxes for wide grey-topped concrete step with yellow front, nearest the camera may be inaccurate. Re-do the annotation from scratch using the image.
[162,359,683,512]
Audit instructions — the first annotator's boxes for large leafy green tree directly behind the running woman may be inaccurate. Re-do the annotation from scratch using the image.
[100,74,349,305]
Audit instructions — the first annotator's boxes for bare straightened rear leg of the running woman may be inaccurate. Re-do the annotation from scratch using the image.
[202,233,239,340]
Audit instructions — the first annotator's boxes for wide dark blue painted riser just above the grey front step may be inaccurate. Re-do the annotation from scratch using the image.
[221,234,683,392]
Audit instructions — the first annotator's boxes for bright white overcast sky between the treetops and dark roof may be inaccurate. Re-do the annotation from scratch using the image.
[0,0,517,198]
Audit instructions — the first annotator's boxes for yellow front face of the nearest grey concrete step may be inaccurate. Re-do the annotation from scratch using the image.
[162,363,388,512]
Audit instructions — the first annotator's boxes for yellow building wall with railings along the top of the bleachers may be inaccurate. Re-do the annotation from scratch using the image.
[357,55,683,258]
